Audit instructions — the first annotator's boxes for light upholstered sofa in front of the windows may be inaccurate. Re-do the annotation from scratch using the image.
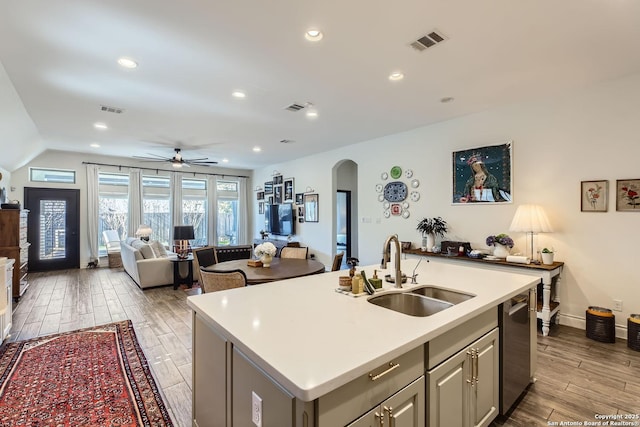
[120,237,174,289]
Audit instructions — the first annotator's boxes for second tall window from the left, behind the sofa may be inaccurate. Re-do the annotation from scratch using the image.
[142,176,172,246]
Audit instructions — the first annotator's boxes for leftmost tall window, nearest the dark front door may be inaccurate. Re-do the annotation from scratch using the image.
[98,173,129,256]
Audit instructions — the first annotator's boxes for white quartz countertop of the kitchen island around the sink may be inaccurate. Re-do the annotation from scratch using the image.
[187,259,540,401]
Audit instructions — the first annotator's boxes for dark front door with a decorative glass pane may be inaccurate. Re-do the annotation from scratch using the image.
[24,187,80,271]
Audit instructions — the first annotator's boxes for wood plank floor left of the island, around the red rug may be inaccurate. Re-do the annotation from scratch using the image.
[9,268,199,427]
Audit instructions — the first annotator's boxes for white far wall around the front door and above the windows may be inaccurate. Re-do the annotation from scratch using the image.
[9,151,254,267]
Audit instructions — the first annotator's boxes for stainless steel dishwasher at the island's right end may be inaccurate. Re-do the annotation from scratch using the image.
[498,291,535,415]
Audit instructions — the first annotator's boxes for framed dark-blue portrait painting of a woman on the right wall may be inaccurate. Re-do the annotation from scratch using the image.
[451,141,513,205]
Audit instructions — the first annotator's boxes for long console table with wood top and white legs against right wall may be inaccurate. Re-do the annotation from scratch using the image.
[403,249,564,336]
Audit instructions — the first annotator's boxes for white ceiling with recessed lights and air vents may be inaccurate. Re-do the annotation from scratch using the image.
[0,0,640,169]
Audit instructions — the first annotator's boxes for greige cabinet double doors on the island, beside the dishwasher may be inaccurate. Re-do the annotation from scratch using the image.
[427,329,499,427]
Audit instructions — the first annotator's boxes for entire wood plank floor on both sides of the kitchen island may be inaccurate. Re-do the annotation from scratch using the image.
[10,267,640,427]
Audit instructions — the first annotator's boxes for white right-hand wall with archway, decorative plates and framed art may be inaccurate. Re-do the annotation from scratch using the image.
[255,75,640,332]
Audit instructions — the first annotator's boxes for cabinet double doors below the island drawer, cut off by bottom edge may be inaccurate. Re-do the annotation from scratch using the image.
[347,376,424,427]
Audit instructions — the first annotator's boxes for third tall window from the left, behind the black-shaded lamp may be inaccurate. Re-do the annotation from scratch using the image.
[182,178,208,246]
